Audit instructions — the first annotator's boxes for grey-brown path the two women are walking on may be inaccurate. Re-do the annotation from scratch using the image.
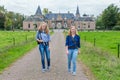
[0,31,88,80]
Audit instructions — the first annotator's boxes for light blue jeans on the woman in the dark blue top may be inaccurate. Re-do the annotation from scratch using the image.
[68,49,78,72]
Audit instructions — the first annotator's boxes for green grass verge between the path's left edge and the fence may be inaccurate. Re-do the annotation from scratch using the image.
[0,41,37,73]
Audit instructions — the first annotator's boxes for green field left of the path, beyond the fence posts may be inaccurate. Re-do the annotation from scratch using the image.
[0,31,36,49]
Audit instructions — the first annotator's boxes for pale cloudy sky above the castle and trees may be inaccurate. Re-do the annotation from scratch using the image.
[0,0,120,16]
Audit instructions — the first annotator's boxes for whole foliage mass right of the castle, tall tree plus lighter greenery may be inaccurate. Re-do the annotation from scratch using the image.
[96,4,120,30]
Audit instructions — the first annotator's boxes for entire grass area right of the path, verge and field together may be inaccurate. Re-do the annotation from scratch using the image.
[79,32,120,80]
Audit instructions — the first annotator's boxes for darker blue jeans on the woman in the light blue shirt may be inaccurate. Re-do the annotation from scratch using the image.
[39,44,50,69]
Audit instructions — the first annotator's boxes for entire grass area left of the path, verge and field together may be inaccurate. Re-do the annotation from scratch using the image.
[0,31,37,73]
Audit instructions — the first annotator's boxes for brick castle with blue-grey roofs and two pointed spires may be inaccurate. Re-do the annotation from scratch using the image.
[23,6,95,30]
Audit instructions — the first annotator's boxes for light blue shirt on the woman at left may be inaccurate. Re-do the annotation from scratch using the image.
[36,32,51,42]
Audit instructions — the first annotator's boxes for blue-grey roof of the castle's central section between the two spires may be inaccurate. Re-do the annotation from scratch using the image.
[45,13,74,20]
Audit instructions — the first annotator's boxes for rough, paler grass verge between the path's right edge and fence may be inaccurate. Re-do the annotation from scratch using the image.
[78,42,120,80]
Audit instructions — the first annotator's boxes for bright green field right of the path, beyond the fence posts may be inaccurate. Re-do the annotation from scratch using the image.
[79,31,120,56]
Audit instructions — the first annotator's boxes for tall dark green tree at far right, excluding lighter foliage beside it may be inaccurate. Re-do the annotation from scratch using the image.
[102,4,119,30]
